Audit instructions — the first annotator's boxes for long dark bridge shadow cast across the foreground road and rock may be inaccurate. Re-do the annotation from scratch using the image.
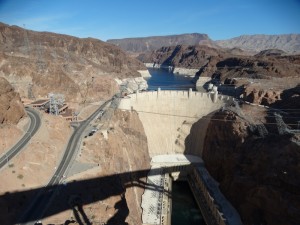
[0,167,188,224]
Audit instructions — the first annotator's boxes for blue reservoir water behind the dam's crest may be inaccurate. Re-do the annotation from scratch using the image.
[146,68,195,91]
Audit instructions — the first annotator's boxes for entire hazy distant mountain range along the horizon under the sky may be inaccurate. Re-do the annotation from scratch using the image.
[107,33,300,54]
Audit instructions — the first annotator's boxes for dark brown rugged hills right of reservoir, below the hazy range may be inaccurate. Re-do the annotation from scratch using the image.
[138,45,300,81]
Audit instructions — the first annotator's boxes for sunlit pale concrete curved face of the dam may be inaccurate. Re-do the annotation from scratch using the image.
[119,90,232,157]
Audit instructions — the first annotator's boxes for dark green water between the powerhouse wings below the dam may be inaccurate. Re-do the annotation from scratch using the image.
[171,182,206,225]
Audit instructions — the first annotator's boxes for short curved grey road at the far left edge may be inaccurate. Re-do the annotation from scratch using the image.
[0,108,41,169]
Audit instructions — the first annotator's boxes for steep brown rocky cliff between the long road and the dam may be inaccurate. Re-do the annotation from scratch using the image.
[47,108,150,224]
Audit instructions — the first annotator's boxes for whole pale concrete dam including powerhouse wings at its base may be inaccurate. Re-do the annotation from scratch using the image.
[119,88,242,225]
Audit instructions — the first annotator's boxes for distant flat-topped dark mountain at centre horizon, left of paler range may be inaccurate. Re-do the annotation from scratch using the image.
[107,33,214,53]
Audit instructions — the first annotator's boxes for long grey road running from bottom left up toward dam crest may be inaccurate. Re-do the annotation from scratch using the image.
[20,100,111,224]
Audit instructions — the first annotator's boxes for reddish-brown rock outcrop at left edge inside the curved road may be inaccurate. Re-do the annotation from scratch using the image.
[0,77,25,125]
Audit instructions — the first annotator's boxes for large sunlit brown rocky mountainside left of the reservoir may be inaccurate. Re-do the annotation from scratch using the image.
[0,23,146,102]
